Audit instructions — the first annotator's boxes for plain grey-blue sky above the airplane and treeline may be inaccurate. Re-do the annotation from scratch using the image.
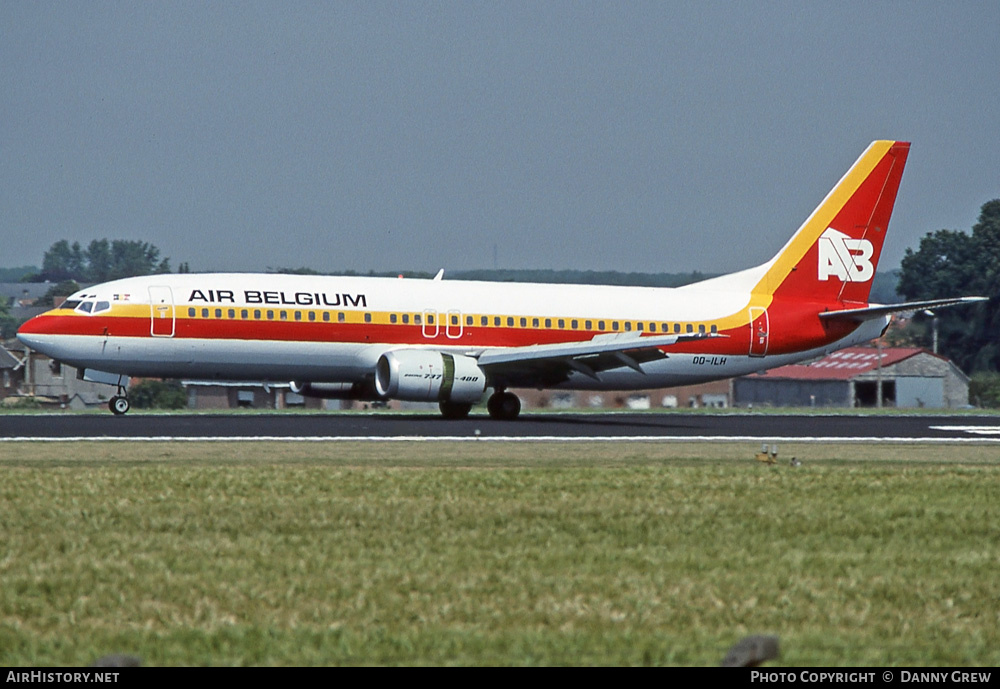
[0,0,1000,272]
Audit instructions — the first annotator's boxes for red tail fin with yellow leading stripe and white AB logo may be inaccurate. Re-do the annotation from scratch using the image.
[755,141,910,304]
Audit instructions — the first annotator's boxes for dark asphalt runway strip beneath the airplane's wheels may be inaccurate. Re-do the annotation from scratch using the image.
[0,412,1000,444]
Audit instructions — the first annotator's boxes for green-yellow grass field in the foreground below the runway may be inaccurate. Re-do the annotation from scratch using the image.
[0,442,1000,666]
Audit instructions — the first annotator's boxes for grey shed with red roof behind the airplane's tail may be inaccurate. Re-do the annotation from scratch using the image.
[733,347,969,409]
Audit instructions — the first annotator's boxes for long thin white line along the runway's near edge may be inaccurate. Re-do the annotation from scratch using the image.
[0,426,1000,445]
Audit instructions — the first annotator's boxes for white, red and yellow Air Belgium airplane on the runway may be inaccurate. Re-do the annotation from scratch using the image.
[17,141,982,419]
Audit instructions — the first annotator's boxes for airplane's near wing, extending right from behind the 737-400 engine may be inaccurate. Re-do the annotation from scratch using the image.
[473,333,720,386]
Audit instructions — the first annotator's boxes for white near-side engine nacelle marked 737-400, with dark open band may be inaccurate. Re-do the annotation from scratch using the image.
[375,349,486,404]
